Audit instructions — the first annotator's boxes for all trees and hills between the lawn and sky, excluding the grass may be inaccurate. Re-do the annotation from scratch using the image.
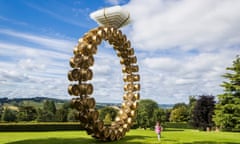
[0,55,240,131]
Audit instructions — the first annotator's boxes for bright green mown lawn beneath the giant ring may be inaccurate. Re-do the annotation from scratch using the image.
[0,129,240,144]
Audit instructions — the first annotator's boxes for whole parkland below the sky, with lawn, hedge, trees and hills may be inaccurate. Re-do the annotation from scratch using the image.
[0,56,240,144]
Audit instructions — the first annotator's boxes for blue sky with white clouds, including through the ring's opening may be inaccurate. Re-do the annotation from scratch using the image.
[0,0,240,104]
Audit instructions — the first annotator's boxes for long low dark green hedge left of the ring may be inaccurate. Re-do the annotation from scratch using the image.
[0,123,83,131]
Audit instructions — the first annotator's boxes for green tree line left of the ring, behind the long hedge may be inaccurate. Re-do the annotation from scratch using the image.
[0,100,77,122]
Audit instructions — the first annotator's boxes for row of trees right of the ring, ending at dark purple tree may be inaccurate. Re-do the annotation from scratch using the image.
[136,95,215,130]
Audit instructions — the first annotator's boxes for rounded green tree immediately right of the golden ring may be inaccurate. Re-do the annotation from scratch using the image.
[136,99,158,128]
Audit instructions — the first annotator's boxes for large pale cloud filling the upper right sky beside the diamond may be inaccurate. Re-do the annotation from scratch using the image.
[125,0,240,51]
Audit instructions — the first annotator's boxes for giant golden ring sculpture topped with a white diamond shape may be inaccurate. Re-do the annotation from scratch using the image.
[68,6,140,141]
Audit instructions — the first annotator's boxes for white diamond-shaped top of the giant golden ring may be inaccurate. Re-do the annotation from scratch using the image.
[90,6,130,28]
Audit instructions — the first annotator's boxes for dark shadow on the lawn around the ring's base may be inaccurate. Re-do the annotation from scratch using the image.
[6,136,149,144]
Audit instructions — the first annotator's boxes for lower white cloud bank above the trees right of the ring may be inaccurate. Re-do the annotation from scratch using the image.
[140,50,237,103]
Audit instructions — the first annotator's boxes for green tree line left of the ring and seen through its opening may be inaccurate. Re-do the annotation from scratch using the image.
[0,100,119,124]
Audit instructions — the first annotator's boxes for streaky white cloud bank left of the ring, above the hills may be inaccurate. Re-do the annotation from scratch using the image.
[0,29,74,98]
